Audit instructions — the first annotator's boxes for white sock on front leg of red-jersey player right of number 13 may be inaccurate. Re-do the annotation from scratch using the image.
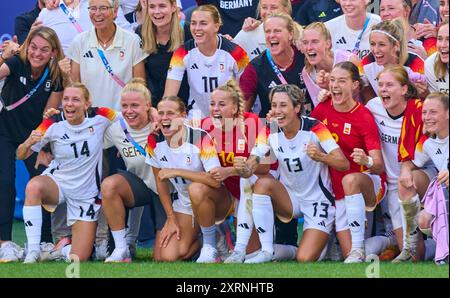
[345,193,366,249]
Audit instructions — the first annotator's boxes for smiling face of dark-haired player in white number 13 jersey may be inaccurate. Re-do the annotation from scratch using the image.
[271,92,300,128]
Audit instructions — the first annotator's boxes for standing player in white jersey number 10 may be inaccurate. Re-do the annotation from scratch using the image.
[164,5,248,120]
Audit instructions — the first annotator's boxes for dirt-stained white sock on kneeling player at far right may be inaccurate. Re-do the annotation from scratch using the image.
[400,194,420,253]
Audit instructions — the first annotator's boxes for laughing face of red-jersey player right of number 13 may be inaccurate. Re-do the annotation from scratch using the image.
[330,67,358,105]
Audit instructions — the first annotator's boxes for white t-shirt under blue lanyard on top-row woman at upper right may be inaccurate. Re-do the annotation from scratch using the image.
[325,13,381,60]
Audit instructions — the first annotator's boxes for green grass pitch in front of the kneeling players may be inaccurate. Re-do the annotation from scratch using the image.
[0,221,449,278]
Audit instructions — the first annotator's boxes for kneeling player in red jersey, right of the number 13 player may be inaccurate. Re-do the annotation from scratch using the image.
[312,62,386,263]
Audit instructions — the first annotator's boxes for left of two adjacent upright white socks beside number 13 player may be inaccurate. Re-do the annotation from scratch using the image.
[234,178,254,253]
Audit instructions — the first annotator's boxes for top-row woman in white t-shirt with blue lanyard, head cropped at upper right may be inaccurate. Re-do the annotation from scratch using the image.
[325,0,381,60]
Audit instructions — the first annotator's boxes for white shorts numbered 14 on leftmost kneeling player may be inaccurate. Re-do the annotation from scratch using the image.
[42,174,102,227]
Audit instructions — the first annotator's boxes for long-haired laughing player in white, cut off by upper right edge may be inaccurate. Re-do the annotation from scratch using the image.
[425,21,450,94]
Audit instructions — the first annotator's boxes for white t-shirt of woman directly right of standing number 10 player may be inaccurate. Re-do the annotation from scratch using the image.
[233,24,267,61]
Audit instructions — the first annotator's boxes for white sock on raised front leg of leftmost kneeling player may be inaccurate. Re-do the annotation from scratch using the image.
[23,205,42,251]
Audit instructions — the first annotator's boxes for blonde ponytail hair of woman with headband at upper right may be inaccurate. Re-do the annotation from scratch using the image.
[372,19,408,65]
